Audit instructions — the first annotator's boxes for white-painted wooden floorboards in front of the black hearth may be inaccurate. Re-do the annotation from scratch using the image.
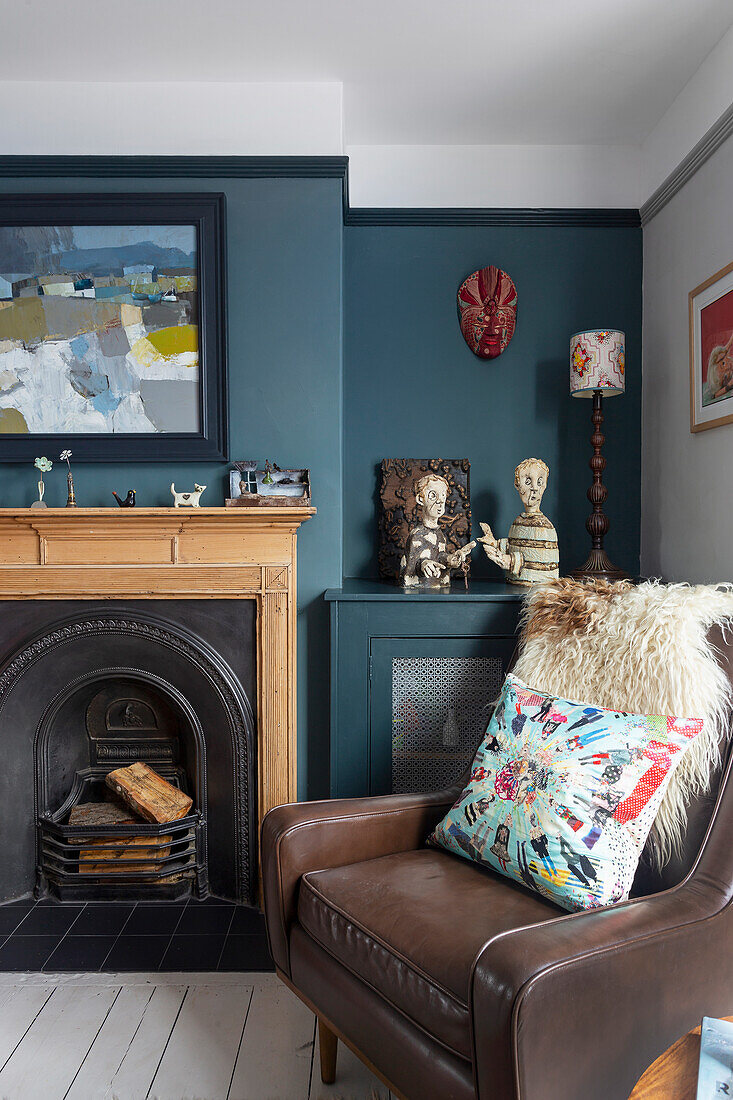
[0,974,390,1100]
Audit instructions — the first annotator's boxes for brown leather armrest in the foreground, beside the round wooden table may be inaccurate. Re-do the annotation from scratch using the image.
[470,880,717,1100]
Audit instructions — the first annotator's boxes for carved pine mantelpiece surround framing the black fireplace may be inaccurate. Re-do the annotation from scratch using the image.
[0,507,316,840]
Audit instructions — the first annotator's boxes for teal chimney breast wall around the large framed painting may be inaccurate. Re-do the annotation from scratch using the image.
[0,178,343,796]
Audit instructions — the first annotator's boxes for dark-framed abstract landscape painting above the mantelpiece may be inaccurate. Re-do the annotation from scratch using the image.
[0,193,227,462]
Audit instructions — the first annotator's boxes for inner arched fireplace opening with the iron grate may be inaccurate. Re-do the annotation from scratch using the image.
[35,668,208,900]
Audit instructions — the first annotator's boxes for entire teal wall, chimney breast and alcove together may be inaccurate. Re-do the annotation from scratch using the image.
[0,169,642,798]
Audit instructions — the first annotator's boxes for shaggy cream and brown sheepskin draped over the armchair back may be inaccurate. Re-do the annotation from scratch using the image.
[513,579,733,866]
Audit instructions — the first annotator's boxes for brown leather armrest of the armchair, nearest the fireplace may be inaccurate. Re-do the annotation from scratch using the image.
[260,785,453,977]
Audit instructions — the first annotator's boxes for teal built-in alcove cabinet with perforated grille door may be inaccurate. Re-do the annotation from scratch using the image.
[326,581,522,798]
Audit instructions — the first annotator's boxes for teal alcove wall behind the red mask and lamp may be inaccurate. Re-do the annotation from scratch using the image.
[343,226,642,579]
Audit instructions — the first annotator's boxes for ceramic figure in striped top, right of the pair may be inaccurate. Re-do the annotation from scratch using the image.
[479,459,560,587]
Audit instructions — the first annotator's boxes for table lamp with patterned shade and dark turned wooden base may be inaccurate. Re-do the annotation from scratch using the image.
[570,329,628,581]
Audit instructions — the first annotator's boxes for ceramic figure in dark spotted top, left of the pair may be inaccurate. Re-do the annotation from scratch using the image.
[400,474,475,589]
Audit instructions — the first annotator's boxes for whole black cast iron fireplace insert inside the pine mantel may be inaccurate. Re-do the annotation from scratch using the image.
[0,600,256,902]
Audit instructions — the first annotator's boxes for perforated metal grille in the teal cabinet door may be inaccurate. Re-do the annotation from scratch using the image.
[392,657,503,794]
